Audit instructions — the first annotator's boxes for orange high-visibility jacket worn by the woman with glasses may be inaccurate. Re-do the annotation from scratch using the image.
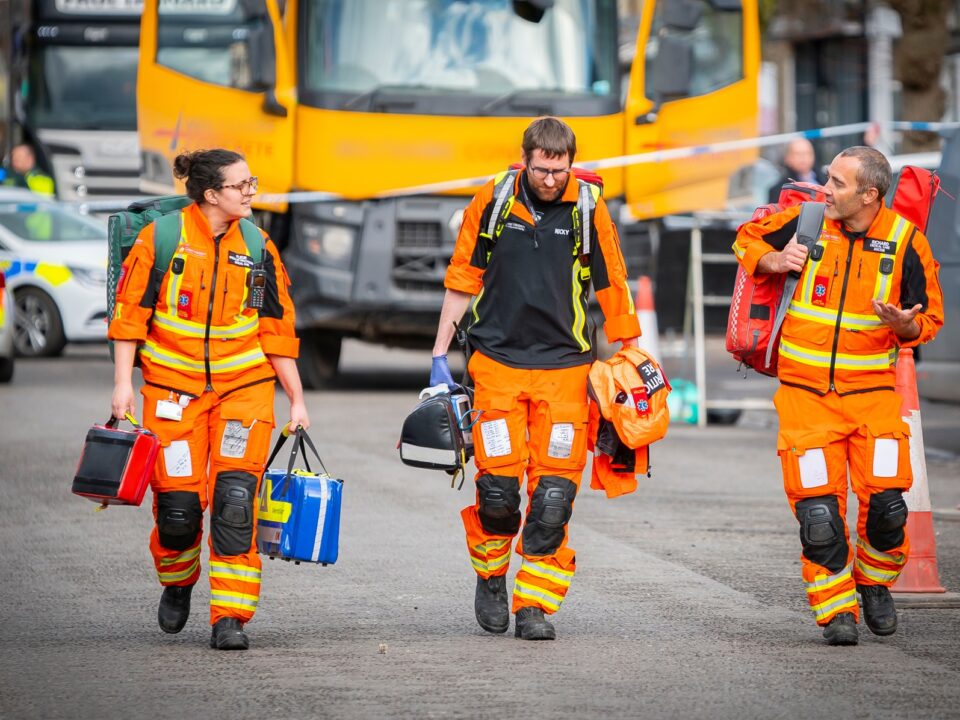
[108,204,299,396]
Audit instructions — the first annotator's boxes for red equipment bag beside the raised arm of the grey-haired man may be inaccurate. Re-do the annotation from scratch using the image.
[727,182,825,377]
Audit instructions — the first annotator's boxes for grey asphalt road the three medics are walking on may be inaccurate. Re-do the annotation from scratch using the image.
[0,346,960,719]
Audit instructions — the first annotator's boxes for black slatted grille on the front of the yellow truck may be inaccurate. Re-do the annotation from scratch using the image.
[390,220,452,292]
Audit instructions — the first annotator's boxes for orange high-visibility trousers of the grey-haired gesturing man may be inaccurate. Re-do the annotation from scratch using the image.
[774,385,913,625]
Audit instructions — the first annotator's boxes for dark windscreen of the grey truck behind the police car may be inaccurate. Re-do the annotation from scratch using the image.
[27,45,137,130]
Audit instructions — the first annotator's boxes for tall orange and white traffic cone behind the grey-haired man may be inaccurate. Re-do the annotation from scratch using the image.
[891,348,946,593]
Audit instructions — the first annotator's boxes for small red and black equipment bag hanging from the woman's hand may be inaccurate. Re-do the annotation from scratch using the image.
[73,413,160,506]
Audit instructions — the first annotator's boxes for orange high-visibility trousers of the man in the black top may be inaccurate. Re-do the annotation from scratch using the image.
[461,352,590,613]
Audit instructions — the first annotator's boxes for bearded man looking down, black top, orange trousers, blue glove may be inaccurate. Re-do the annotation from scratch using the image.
[430,118,640,640]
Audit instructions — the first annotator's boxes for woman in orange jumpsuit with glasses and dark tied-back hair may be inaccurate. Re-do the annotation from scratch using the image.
[109,150,310,650]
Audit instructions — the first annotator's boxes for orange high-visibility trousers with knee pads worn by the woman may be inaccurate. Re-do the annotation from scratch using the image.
[141,379,274,625]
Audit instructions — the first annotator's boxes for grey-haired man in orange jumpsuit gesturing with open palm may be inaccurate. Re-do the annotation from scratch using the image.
[733,147,943,645]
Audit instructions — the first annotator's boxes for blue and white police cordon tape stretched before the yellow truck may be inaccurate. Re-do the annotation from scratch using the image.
[75,121,960,212]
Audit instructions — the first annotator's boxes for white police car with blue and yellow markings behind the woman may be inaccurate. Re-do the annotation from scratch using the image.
[0,189,107,357]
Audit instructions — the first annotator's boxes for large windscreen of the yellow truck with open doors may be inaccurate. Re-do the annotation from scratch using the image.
[298,0,620,116]
